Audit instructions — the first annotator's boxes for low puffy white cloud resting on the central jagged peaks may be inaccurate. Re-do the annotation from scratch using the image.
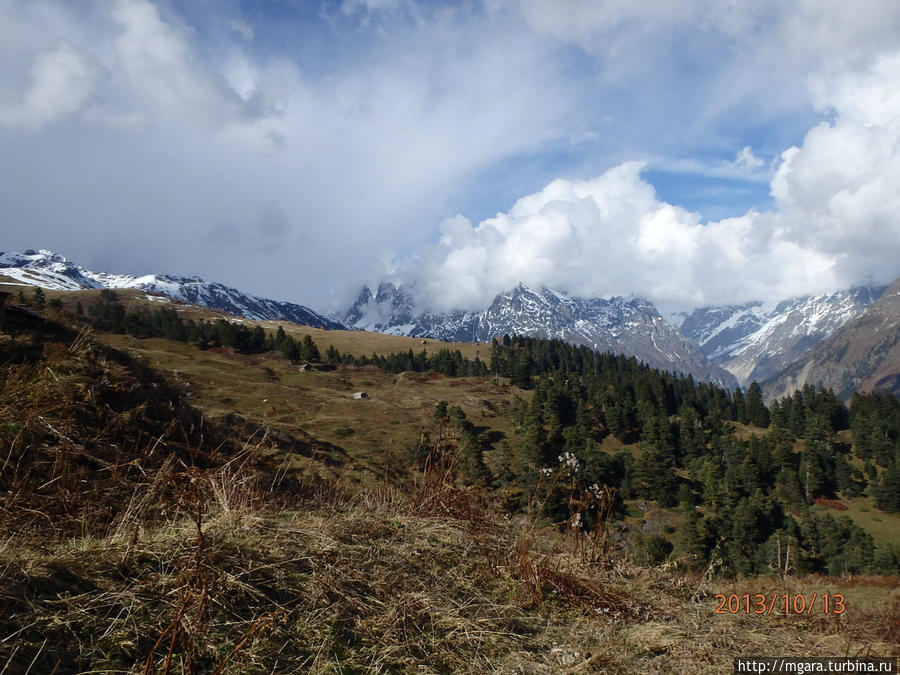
[407,162,839,310]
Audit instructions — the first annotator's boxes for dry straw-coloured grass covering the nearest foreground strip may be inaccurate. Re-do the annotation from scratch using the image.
[0,452,900,673]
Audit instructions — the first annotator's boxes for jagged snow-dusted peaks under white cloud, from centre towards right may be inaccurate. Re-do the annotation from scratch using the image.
[337,284,885,396]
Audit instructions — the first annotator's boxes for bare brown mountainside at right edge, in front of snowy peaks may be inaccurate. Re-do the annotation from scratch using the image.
[765,279,900,399]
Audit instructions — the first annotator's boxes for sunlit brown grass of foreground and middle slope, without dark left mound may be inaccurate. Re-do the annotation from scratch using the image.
[0,298,900,673]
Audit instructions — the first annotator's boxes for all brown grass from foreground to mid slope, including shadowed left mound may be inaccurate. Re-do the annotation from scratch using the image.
[0,308,900,673]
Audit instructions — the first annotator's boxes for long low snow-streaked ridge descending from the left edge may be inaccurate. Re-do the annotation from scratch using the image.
[0,250,344,328]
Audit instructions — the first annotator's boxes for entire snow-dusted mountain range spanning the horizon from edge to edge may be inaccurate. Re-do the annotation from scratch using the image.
[0,250,900,397]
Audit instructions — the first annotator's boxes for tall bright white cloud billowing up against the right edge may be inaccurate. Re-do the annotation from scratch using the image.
[772,54,900,283]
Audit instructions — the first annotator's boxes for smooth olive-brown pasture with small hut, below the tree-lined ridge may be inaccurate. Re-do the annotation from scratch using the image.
[94,329,528,486]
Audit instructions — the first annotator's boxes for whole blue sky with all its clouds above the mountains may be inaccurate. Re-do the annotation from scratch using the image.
[0,0,900,309]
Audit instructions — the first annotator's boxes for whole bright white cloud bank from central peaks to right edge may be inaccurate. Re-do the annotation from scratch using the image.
[408,18,900,309]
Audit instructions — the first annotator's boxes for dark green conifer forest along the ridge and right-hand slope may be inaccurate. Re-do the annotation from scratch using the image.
[56,291,900,574]
